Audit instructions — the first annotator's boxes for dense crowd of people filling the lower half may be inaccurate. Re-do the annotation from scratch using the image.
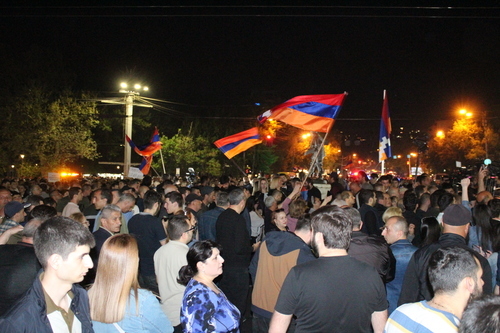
[0,169,500,333]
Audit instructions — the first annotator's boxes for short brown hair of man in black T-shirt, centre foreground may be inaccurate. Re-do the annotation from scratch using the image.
[311,206,352,250]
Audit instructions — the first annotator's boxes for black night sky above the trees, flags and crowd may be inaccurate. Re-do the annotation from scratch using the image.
[0,6,500,156]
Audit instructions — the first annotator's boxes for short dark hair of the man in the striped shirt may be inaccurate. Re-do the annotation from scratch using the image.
[428,247,479,294]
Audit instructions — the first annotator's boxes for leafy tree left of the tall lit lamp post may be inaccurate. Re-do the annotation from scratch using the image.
[1,85,97,172]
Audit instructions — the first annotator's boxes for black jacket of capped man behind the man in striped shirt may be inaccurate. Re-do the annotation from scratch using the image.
[398,233,493,306]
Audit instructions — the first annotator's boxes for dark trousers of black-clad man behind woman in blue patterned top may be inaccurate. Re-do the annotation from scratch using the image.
[219,268,250,318]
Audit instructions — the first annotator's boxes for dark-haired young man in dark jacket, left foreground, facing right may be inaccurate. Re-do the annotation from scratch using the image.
[0,216,95,333]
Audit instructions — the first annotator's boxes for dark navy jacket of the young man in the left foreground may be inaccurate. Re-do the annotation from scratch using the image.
[0,277,94,333]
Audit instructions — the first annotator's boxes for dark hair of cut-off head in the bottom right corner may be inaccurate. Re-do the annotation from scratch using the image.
[458,295,500,333]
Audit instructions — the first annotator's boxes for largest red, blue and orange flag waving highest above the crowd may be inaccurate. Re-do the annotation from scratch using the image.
[257,93,346,132]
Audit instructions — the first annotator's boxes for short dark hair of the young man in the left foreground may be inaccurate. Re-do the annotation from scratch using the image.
[33,216,95,269]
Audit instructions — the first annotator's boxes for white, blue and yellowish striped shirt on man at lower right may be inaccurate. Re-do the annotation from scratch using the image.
[384,301,460,333]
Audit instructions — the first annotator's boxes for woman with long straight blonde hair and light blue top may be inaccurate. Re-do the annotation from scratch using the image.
[89,234,174,333]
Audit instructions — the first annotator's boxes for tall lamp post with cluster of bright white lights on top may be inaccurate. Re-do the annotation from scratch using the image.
[101,82,153,177]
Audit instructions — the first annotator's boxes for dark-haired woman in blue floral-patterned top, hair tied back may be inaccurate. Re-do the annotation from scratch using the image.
[178,240,240,333]
